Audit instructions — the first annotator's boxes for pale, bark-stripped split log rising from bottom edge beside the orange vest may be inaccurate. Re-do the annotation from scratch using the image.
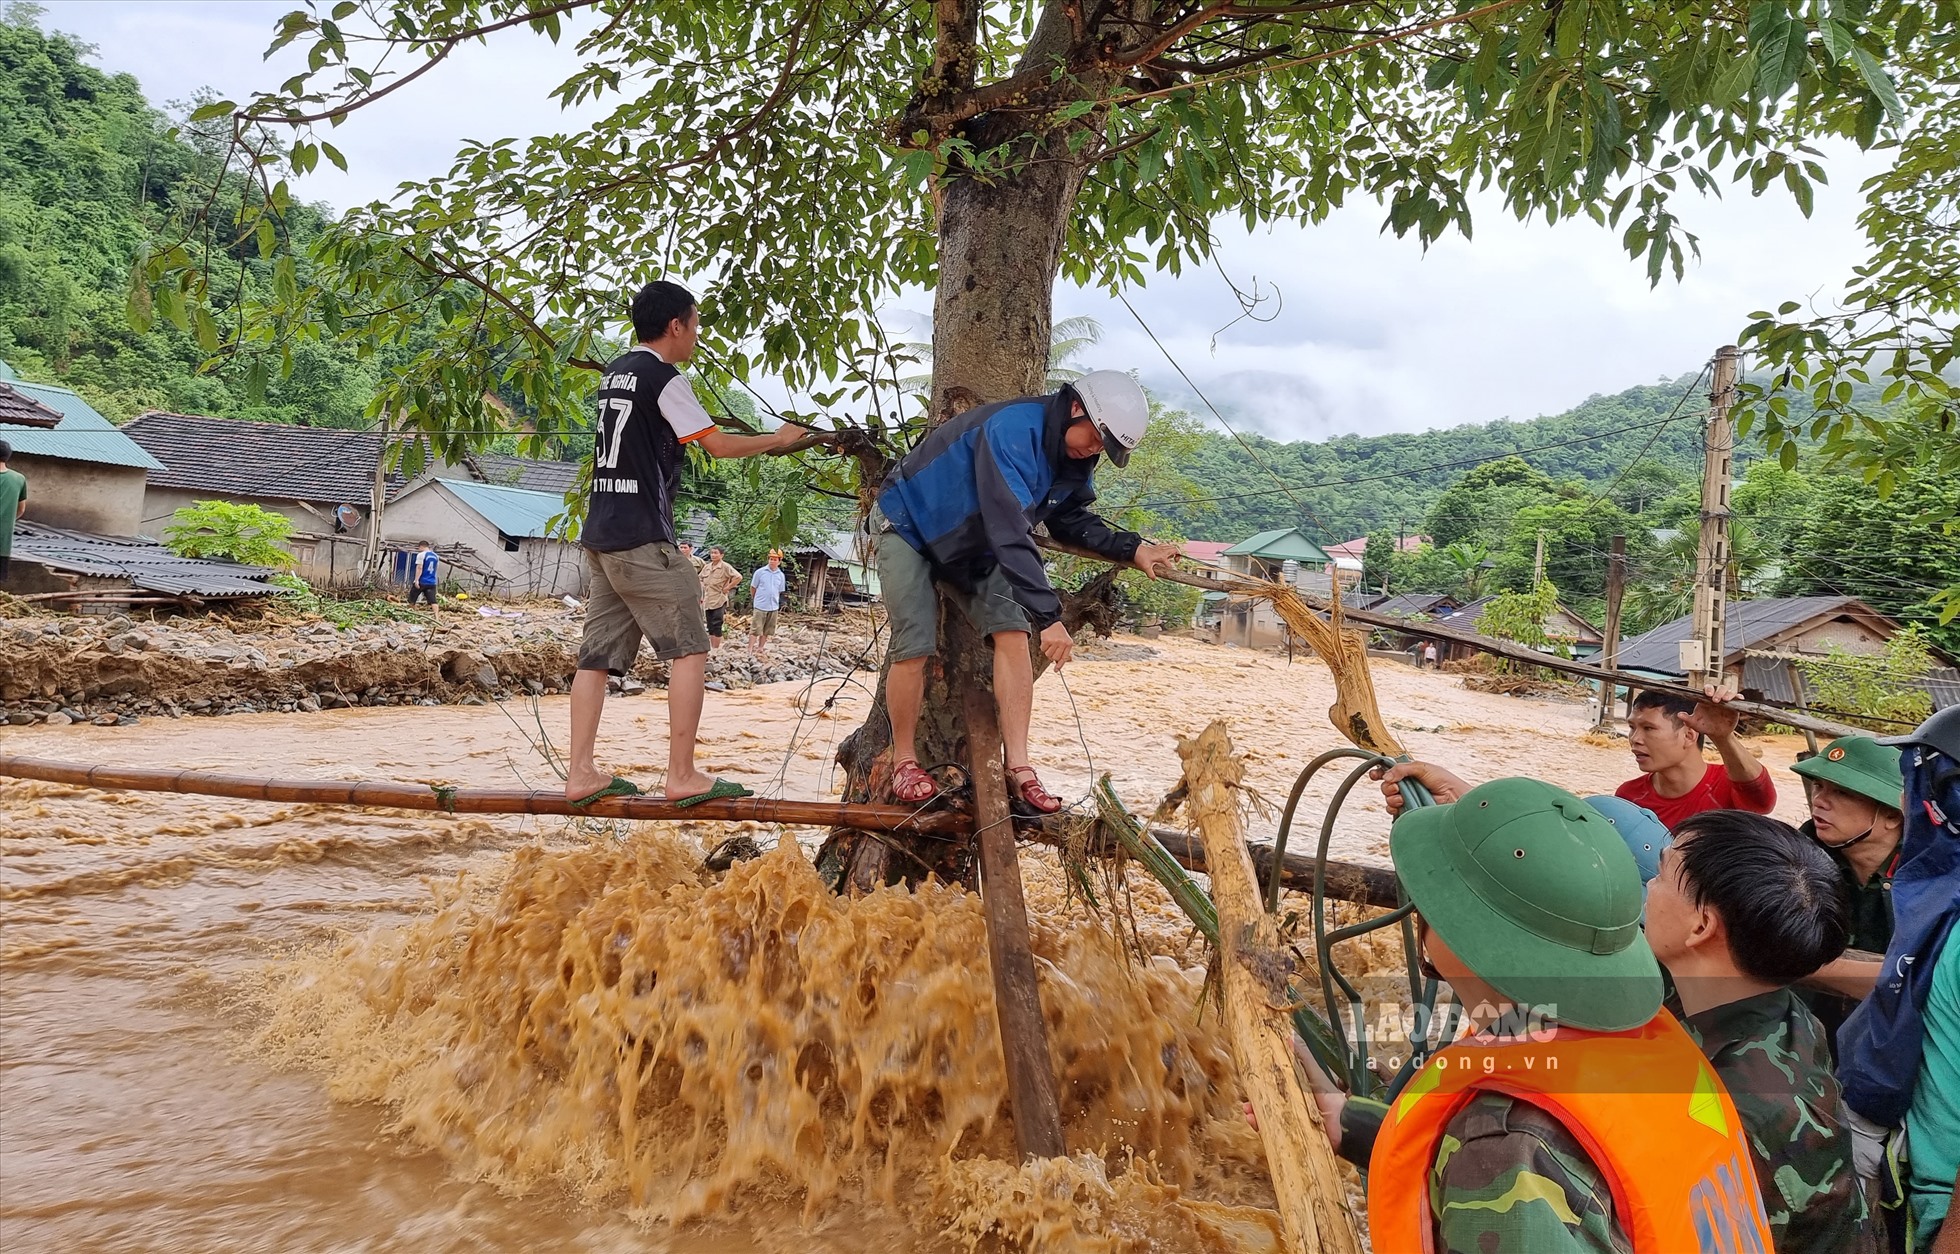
[1178,721,1362,1254]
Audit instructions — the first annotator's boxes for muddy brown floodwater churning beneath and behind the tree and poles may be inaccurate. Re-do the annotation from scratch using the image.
[0,643,1801,1254]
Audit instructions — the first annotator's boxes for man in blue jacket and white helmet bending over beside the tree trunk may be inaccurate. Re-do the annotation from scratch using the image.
[872,370,1178,813]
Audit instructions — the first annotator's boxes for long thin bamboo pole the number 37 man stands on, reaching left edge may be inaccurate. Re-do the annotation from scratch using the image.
[0,756,972,837]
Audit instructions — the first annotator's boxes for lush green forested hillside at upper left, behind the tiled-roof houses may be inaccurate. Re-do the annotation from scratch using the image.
[0,6,384,427]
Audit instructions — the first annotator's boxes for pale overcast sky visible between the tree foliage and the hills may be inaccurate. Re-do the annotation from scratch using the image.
[43,0,1876,439]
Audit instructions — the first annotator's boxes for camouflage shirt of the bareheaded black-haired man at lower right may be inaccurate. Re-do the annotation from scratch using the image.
[1682,989,1880,1254]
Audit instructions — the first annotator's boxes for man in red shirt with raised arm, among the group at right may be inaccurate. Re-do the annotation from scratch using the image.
[1615,688,1776,831]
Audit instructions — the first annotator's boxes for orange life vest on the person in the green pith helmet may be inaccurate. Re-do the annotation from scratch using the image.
[1368,1011,1772,1254]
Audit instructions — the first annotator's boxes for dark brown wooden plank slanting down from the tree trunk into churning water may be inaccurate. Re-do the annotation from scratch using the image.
[964,684,1068,1158]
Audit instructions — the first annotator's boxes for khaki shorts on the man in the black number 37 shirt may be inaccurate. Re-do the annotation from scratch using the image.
[578,543,708,674]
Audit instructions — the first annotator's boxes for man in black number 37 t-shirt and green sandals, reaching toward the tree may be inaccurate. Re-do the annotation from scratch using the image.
[564,282,809,803]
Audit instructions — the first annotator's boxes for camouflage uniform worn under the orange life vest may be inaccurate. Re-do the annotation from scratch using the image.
[1341,1093,1630,1254]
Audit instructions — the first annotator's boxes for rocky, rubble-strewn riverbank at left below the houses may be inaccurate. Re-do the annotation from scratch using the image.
[0,602,880,727]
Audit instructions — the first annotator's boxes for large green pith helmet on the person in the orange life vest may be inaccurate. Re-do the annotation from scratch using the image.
[1388,780,1660,1033]
